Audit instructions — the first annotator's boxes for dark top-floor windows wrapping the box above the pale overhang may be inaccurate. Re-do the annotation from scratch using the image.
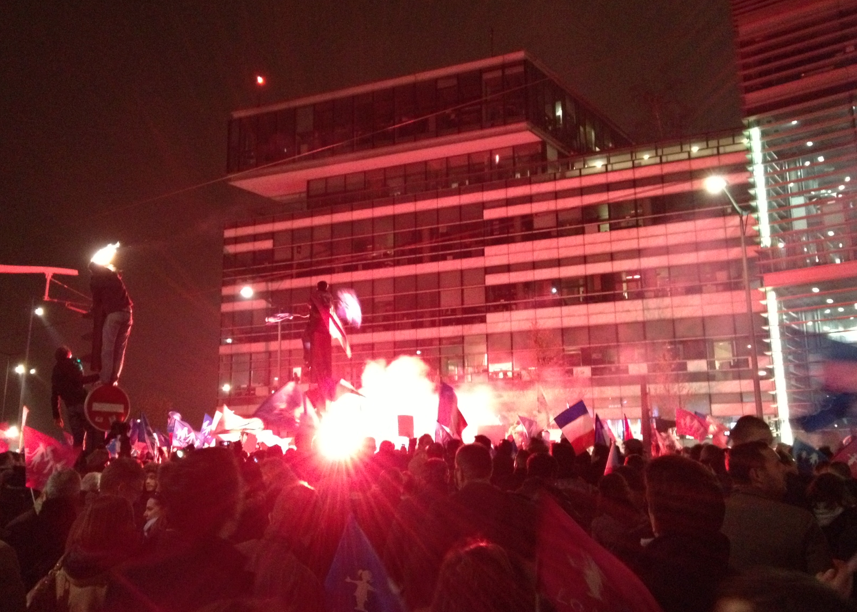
[227,62,630,172]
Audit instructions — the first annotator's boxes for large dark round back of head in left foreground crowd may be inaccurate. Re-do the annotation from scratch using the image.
[159,447,242,538]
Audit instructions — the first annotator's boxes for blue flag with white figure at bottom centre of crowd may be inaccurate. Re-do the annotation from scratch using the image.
[324,516,403,612]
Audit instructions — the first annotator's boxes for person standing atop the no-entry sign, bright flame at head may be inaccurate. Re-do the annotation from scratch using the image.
[89,242,133,385]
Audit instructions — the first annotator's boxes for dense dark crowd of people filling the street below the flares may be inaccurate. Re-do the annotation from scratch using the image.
[0,416,857,612]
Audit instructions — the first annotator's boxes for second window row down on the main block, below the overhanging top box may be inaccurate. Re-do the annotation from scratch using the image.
[221,260,743,341]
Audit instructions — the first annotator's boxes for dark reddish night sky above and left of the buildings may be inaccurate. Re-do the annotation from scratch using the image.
[0,0,740,435]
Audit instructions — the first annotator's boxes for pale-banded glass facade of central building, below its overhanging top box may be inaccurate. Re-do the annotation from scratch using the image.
[221,120,771,418]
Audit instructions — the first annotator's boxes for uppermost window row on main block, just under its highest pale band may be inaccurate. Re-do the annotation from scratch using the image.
[223,192,724,283]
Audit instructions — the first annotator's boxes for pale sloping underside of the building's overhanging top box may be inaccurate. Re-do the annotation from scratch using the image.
[229,122,540,199]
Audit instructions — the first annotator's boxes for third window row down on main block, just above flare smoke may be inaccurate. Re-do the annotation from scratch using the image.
[221,316,750,400]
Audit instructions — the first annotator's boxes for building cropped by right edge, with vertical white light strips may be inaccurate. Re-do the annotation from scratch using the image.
[731,0,857,439]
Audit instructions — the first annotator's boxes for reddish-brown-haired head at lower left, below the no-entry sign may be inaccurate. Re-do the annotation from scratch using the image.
[66,495,139,557]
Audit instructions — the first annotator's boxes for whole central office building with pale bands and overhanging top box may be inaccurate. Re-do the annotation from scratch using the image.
[220,52,775,428]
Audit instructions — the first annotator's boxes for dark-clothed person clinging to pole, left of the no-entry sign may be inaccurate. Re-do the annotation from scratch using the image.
[51,346,104,454]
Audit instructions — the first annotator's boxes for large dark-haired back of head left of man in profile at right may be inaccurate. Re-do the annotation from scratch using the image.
[646,451,724,536]
